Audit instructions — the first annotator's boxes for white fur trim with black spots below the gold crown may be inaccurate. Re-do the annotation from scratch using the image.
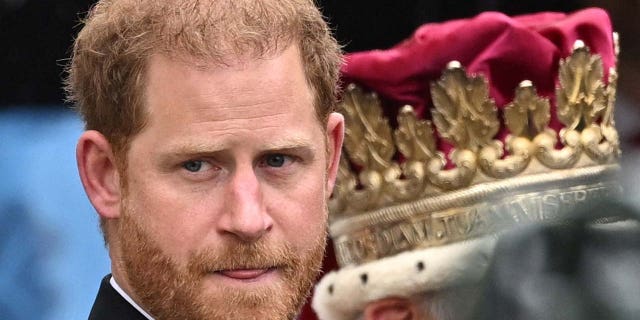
[312,236,496,320]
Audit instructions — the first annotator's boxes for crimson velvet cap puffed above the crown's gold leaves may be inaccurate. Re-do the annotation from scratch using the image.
[341,8,616,158]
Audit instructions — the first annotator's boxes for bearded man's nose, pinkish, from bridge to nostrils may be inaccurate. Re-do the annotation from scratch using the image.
[220,167,273,242]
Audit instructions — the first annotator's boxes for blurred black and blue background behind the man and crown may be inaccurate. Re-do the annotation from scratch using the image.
[0,0,640,319]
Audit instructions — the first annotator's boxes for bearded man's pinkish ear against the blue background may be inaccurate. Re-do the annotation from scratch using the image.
[76,130,122,219]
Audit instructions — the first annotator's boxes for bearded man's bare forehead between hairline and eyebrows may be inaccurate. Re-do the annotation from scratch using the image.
[137,46,322,151]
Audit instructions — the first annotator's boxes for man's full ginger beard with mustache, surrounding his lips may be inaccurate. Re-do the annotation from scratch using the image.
[118,206,326,320]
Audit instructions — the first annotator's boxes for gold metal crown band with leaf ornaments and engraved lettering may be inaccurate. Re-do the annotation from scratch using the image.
[329,34,621,266]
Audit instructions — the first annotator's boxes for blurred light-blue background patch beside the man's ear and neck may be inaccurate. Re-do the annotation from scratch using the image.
[0,107,109,319]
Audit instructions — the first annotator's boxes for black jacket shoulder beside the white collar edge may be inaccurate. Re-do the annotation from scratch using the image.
[89,274,147,320]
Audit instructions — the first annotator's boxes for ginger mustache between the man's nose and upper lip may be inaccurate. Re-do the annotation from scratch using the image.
[188,241,301,275]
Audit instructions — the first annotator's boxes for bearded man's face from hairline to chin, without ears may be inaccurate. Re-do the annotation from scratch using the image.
[112,46,329,319]
